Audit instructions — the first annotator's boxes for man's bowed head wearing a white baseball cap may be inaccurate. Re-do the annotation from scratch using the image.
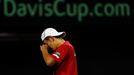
[41,28,66,49]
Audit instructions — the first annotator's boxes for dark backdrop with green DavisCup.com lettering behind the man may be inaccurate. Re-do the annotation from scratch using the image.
[0,0,134,75]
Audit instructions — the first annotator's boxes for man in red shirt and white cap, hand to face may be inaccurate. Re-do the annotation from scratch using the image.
[40,28,78,75]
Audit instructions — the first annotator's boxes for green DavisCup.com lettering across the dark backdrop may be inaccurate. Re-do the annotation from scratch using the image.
[4,0,130,22]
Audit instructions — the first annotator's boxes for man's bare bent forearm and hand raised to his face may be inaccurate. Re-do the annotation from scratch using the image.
[40,44,56,66]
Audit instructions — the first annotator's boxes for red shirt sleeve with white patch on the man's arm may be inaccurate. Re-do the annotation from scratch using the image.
[52,45,69,63]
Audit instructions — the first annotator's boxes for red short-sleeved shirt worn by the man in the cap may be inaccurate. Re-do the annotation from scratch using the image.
[52,41,78,75]
